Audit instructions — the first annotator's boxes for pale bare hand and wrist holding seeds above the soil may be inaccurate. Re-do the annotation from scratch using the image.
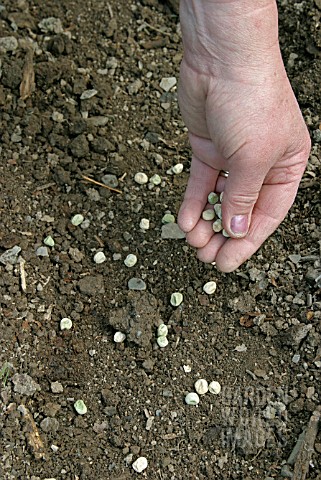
[178,0,311,272]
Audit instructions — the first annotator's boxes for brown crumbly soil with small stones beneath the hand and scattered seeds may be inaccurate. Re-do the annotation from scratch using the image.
[0,0,321,480]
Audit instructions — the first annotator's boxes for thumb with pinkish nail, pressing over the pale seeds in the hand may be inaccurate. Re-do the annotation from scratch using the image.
[222,161,266,238]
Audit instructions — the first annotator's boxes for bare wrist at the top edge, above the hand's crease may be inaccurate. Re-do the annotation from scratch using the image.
[180,0,283,76]
